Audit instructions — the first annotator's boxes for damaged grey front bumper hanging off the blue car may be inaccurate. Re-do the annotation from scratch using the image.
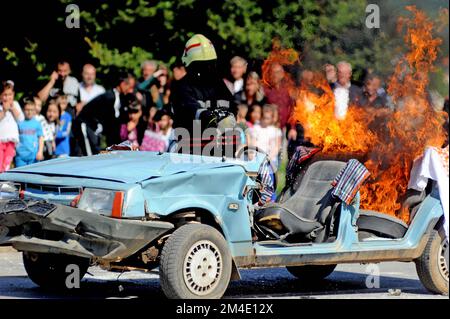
[0,200,174,262]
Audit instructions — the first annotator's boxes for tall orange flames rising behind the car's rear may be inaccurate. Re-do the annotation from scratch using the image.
[263,6,445,222]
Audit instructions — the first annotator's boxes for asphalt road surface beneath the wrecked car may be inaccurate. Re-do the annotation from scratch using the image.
[0,247,448,299]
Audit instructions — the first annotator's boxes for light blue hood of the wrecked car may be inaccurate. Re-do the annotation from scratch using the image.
[5,151,259,183]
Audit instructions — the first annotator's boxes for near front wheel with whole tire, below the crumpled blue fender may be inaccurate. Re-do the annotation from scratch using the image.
[159,224,232,299]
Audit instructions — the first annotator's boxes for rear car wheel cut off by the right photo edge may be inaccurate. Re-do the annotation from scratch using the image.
[415,230,448,295]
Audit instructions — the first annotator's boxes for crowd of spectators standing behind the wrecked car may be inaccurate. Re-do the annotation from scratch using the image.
[0,56,448,172]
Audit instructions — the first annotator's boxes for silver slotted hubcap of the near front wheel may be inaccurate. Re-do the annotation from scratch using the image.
[183,240,222,296]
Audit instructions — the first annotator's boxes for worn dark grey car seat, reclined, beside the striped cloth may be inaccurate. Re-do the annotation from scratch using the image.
[255,160,346,242]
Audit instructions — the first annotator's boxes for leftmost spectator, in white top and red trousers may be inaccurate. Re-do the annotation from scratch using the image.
[0,81,24,173]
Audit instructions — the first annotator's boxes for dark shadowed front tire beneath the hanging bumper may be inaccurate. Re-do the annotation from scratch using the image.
[23,251,90,290]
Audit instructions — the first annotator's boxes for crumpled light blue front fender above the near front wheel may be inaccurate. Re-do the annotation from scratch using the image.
[142,166,254,255]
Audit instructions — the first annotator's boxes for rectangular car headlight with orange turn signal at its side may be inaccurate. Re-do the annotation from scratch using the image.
[77,188,124,218]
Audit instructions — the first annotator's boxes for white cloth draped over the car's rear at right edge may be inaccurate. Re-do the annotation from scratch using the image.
[408,146,449,238]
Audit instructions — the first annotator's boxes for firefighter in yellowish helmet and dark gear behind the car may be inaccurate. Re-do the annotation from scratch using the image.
[170,34,236,154]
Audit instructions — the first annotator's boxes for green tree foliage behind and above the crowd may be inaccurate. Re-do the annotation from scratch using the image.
[0,0,448,94]
